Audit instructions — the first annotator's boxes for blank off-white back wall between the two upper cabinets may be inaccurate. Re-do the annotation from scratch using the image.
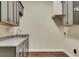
[20,2,64,50]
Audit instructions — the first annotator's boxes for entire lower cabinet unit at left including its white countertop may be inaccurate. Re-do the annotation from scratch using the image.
[0,35,29,57]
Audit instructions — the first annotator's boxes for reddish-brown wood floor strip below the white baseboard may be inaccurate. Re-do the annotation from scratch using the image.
[28,52,69,57]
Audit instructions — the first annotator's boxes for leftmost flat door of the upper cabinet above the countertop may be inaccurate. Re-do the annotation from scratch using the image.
[1,1,8,21]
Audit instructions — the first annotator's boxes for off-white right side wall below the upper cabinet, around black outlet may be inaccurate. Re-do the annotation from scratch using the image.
[65,25,79,56]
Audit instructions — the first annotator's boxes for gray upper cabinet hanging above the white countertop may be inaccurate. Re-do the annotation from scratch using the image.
[0,1,24,26]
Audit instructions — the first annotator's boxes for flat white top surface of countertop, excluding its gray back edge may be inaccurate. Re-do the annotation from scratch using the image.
[0,37,28,47]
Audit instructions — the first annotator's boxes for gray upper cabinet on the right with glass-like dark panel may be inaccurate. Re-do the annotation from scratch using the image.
[62,1,79,25]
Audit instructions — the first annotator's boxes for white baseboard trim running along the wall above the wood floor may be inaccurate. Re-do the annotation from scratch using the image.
[29,49,74,57]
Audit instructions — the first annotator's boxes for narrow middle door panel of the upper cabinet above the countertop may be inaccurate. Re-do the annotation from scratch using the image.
[8,1,14,23]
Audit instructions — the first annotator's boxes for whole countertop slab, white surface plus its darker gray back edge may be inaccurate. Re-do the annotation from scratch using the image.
[0,34,29,47]
